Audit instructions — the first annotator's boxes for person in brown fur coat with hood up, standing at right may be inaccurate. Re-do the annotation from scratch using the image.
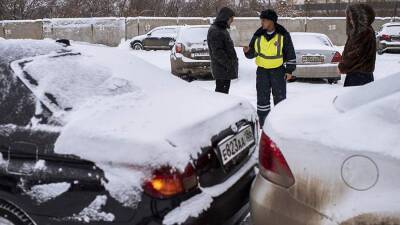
[339,3,376,87]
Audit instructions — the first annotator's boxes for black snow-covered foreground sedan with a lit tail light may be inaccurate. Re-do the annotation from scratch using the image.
[0,40,258,225]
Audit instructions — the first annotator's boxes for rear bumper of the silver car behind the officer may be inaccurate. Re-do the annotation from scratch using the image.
[293,64,341,78]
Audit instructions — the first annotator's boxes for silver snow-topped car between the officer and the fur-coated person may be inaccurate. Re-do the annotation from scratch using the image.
[290,32,342,83]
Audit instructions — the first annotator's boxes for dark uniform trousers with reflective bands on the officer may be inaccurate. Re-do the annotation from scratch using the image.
[256,66,286,127]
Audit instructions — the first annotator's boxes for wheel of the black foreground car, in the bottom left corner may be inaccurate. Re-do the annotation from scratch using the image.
[0,200,35,225]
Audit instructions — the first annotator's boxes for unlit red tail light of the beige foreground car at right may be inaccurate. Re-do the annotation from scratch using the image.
[259,132,294,188]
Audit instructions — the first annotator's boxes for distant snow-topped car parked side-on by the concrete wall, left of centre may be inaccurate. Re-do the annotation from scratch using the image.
[130,26,180,50]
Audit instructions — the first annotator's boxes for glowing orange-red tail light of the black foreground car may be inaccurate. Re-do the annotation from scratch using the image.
[143,164,198,199]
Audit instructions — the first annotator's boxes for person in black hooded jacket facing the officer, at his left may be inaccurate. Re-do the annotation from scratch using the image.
[207,7,238,94]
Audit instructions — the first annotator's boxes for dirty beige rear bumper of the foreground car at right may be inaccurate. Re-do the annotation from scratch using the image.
[250,174,335,225]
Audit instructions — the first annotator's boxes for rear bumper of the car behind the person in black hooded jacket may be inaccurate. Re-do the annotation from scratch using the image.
[171,57,211,78]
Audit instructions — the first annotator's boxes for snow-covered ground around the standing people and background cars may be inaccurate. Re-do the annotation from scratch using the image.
[127,48,400,110]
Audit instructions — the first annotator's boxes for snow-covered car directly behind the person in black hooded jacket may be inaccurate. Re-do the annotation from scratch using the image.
[170,25,211,79]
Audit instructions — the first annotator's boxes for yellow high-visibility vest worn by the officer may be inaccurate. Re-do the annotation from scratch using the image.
[254,34,283,69]
